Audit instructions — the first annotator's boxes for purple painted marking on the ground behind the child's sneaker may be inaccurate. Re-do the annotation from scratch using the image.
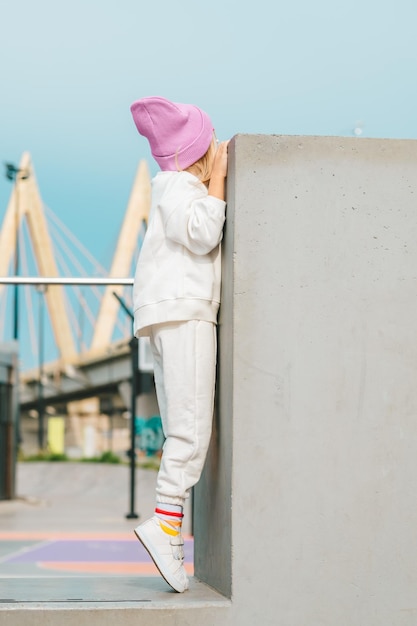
[5,539,194,563]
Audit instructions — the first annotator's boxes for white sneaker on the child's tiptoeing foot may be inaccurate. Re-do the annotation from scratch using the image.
[135,515,188,593]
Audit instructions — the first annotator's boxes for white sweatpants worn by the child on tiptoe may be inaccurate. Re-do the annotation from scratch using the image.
[150,320,217,505]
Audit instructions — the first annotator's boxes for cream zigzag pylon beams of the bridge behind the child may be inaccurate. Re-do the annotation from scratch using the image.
[0,152,151,363]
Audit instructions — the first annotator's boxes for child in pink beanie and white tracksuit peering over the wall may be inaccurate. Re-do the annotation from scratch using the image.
[131,97,227,592]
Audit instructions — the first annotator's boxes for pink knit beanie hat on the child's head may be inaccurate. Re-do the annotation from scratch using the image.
[130,96,213,171]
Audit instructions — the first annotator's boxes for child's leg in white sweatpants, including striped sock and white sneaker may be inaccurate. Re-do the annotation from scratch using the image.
[135,321,216,592]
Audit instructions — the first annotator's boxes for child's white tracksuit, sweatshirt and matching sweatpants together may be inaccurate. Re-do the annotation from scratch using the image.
[133,172,226,504]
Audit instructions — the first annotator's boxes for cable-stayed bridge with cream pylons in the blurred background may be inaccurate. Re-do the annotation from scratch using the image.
[0,153,150,450]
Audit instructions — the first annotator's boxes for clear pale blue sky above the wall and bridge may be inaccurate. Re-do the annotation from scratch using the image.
[0,0,417,267]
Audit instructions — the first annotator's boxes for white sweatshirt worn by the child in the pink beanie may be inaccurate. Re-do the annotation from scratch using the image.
[133,172,226,337]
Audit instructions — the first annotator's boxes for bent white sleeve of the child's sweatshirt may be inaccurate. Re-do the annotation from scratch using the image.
[160,173,226,255]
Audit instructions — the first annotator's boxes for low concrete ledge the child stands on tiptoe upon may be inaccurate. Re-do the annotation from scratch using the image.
[0,576,231,626]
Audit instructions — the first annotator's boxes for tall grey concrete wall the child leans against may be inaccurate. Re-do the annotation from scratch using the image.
[195,135,417,626]
